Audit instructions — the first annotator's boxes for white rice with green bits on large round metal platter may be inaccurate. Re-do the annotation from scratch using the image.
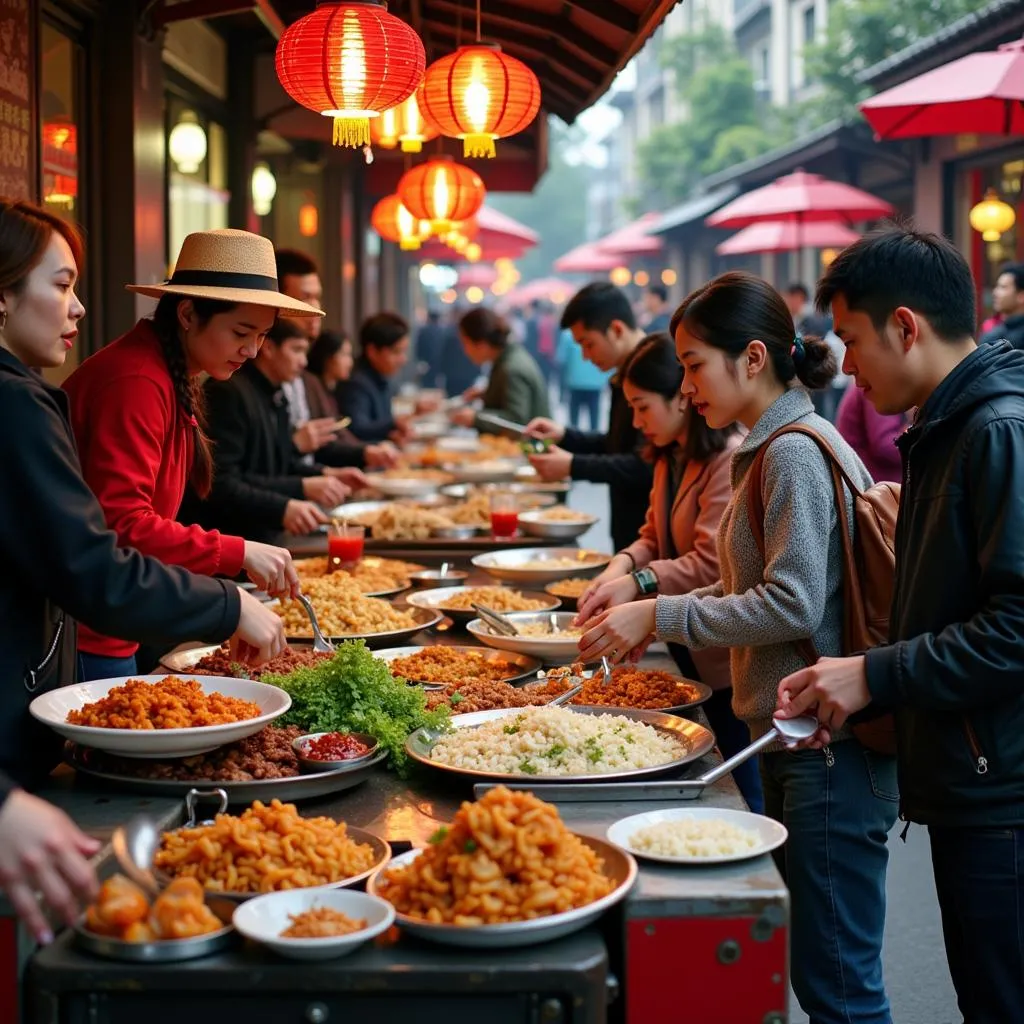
[430,708,685,775]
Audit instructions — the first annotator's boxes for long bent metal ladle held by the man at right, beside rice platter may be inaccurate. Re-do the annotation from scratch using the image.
[473,712,818,804]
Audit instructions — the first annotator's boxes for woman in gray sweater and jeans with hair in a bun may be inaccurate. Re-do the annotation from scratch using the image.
[580,272,898,1024]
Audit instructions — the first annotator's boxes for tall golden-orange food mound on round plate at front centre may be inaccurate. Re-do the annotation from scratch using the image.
[378,786,614,927]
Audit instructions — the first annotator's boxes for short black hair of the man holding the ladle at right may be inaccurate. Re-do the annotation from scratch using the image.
[815,224,978,341]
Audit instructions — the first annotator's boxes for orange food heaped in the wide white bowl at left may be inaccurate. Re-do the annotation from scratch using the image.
[68,676,263,729]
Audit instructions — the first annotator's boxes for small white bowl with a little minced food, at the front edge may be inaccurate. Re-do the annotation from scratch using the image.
[232,889,394,961]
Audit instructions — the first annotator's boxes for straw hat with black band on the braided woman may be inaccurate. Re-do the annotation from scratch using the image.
[125,227,324,316]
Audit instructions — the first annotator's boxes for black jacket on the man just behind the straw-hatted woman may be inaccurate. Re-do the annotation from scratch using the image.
[178,362,324,544]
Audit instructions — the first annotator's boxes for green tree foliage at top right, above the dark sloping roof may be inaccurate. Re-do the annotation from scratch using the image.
[804,0,989,124]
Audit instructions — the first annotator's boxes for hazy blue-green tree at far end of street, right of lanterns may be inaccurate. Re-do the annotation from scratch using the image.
[487,118,588,281]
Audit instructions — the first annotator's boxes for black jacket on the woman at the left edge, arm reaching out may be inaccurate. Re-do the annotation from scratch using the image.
[0,349,240,803]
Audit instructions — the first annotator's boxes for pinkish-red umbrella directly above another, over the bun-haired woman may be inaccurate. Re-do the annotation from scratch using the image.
[705,170,893,228]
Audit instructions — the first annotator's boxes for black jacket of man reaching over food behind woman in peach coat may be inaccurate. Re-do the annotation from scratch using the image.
[561,376,654,551]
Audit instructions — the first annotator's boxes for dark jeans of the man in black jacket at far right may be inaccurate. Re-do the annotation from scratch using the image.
[928,825,1024,1024]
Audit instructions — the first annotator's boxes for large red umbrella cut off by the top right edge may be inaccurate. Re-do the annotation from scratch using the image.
[860,39,1024,139]
